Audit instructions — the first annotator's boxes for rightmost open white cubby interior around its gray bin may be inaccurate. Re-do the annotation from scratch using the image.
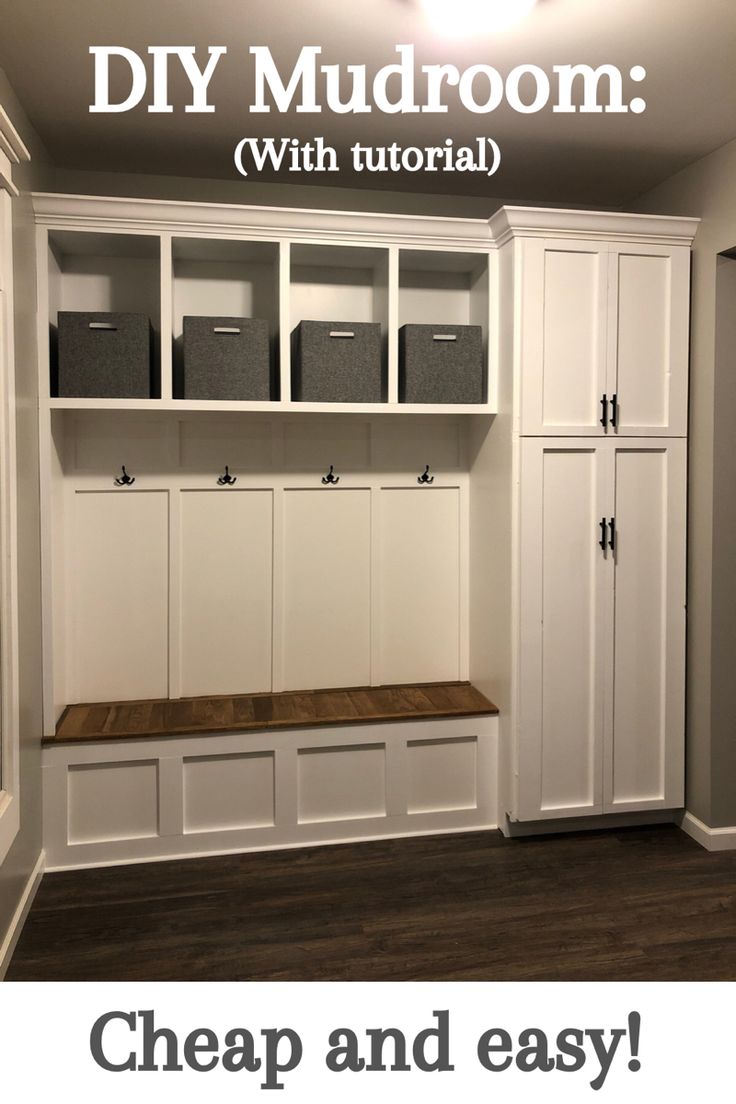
[398,250,494,403]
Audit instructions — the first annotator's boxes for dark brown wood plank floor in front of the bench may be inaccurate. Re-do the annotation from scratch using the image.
[8,826,736,980]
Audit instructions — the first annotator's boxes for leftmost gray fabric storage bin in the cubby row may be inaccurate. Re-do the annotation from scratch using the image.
[57,310,152,399]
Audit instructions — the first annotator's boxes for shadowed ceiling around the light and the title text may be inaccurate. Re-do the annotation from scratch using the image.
[0,0,736,206]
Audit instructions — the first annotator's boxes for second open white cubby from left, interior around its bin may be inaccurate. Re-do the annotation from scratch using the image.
[171,237,281,399]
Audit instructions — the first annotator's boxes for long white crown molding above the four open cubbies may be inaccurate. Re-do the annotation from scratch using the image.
[32,192,494,250]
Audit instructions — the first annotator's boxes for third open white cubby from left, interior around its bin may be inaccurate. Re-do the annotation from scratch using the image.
[284,242,395,401]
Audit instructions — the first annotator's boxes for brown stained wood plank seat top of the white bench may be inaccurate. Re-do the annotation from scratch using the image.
[44,682,498,744]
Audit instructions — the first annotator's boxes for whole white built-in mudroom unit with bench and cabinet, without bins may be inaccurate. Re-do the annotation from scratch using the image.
[25,194,696,869]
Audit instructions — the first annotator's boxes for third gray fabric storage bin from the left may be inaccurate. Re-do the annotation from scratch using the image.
[291,320,383,403]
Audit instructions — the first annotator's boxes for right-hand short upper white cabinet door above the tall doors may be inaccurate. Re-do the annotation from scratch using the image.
[604,245,690,437]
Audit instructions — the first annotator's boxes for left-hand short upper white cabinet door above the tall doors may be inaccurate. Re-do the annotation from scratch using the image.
[521,240,608,436]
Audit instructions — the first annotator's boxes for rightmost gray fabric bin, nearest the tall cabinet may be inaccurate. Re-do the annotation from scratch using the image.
[398,323,483,403]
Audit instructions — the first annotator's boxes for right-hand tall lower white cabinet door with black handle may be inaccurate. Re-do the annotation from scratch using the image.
[605,440,686,811]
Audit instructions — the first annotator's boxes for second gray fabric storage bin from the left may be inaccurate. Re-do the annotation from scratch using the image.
[183,316,271,401]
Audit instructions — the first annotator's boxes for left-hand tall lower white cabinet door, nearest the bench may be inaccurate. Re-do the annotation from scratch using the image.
[516,439,614,820]
